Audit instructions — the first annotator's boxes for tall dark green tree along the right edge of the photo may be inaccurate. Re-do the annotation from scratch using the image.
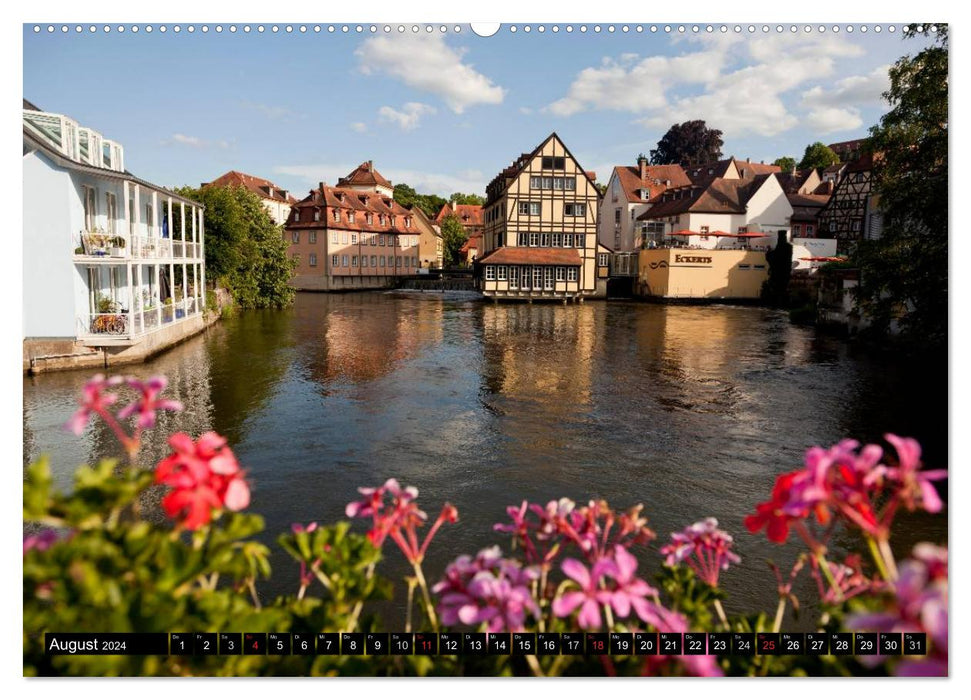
[853,25,948,349]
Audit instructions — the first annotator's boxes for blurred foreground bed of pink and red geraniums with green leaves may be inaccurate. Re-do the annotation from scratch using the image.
[23,375,948,676]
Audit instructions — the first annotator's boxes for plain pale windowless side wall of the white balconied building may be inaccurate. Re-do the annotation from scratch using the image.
[23,151,80,338]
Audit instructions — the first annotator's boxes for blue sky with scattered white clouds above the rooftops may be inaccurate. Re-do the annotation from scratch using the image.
[24,25,926,196]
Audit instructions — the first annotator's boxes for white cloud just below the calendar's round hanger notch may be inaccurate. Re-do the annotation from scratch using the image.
[354,34,506,114]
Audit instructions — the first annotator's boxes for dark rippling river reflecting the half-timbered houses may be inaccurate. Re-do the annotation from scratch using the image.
[24,292,947,630]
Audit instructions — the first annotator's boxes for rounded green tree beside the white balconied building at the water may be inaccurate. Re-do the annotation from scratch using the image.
[177,186,296,309]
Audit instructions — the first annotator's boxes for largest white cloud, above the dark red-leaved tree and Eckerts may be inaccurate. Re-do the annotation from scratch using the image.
[547,34,876,138]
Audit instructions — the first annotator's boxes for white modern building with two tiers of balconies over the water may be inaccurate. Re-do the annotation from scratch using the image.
[23,102,206,364]
